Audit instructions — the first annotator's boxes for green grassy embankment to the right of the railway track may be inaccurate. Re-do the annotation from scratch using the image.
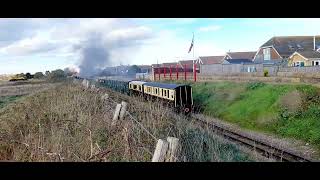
[193,82,320,148]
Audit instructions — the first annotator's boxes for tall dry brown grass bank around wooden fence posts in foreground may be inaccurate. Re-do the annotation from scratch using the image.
[0,84,255,161]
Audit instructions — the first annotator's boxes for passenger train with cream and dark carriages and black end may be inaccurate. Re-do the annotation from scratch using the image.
[98,79,193,114]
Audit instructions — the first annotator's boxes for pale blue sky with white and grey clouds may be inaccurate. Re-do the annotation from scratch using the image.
[0,18,320,74]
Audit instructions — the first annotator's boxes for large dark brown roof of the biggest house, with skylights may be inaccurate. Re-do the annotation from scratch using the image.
[261,36,320,57]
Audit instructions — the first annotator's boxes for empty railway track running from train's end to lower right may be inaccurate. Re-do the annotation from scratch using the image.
[192,116,313,162]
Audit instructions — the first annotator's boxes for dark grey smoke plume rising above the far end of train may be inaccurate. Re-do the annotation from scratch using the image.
[79,33,111,77]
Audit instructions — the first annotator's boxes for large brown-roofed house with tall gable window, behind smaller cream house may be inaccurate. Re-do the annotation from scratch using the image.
[253,36,320,64]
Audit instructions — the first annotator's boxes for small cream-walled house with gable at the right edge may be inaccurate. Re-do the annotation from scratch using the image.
[288,51,320,67]
